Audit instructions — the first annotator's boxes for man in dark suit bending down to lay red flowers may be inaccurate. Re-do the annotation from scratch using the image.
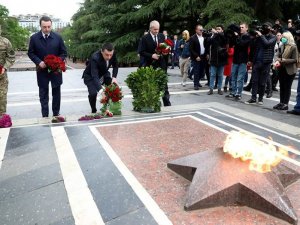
[82,43,118,113]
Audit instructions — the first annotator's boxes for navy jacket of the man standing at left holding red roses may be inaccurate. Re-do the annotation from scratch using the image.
[28,31,67,88]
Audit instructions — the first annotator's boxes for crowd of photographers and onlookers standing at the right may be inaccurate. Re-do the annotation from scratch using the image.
[138,20,300,115]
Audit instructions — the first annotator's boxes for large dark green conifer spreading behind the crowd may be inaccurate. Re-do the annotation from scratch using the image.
[63,0,300,64]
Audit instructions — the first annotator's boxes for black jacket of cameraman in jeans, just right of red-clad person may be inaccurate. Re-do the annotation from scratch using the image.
[233,34,251,64]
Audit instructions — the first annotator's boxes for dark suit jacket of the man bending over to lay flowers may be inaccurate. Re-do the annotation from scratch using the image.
[82,51,118,91]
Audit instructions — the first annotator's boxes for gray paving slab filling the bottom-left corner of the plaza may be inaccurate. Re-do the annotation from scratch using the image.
[0,182,72,225]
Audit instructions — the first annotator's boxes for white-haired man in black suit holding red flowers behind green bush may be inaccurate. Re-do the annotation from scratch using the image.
[139,20,171,106]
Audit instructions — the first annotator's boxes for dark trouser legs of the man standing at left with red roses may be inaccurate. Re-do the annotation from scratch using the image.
[39,86,61,117]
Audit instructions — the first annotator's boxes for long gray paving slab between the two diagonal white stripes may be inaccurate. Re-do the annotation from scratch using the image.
[66,127,143,222]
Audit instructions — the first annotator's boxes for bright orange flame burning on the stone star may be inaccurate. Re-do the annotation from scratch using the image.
[223,131,288,173]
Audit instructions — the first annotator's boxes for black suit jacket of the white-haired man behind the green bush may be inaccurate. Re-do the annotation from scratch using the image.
[139,32,167,70]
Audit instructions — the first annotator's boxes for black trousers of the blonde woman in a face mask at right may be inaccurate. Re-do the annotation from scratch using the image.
[279,67,296,105]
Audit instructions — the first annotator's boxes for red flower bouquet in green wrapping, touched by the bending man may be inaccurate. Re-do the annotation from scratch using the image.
[100,83,123,116]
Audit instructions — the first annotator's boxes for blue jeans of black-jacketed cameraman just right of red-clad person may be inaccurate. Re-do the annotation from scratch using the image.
[231,63,247,96]
